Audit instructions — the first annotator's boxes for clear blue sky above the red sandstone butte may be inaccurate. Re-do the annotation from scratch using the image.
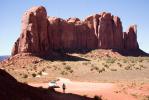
[0,0,149,55]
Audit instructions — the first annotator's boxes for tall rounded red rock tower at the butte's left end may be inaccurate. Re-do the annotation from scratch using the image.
[12,6,49,55]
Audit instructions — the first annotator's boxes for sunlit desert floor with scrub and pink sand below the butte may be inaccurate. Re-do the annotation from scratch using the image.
[0,50,149,100]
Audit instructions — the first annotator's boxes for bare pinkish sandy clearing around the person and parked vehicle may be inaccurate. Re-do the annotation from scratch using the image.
[29,78,149,100]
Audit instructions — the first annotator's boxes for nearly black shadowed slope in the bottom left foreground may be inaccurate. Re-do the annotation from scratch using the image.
[0,69,101,100]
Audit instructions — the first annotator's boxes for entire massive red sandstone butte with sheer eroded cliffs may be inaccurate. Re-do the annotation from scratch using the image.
[12,6,139,55]
